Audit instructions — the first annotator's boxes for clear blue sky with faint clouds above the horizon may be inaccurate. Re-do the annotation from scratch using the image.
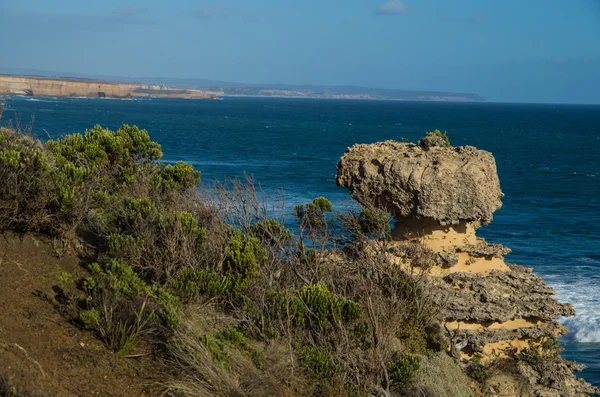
[0,0,600,104]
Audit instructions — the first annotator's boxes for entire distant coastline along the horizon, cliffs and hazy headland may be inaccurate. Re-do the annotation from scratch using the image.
[0,69,486,102]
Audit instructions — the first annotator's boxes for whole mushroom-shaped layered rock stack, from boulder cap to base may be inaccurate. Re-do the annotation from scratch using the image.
[337,139,598,396]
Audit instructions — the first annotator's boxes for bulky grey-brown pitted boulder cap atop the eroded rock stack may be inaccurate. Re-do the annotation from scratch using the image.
[336,141,503,225]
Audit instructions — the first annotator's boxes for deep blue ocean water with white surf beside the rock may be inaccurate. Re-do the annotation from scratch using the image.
[4,97,600,386]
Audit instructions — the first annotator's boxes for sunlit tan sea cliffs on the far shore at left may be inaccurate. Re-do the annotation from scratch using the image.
[0,75,215,99]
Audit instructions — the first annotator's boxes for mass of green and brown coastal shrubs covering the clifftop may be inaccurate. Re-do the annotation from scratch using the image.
[0,126,460,396]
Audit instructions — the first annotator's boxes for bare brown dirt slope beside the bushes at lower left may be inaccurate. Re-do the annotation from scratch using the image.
[0,233,158,396]
